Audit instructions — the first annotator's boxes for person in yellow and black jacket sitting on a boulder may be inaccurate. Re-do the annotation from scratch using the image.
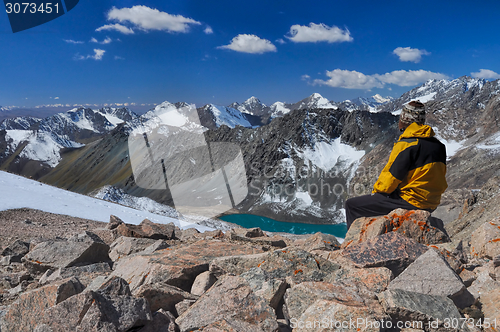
[345,101,448,229]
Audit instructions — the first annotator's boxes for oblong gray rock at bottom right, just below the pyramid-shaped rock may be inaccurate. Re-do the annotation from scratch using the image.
[378,289,461,331]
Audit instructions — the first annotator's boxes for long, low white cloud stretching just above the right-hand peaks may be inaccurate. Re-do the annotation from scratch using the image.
[313,69,448,90]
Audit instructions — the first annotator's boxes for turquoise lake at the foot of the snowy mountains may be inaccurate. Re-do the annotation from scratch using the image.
[219,214,347,238]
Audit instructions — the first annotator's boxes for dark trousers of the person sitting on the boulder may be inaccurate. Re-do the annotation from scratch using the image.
[345,193,432,229]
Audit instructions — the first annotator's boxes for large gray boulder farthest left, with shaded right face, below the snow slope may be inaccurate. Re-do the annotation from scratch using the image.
[23,232,110,274]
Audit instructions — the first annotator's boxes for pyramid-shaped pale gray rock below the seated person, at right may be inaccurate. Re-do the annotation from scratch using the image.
[388,249,474,309]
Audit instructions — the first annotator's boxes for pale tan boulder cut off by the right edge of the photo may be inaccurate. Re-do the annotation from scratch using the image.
[471,217,500,259]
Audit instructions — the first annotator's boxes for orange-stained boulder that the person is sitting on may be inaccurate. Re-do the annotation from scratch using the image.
[342,209,450,248]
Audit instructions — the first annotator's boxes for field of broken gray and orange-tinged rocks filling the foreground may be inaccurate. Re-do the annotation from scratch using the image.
[0,209,500,332]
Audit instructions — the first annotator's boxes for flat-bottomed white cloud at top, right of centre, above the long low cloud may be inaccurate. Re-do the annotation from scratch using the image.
[285,23,353,43]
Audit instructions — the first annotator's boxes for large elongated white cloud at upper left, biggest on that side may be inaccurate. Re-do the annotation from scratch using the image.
[108,5,201,32]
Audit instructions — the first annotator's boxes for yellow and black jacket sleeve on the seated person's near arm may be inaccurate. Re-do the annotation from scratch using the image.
[372,139,418,194]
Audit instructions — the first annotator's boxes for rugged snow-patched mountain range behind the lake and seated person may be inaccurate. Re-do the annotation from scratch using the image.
[0,77,500,223]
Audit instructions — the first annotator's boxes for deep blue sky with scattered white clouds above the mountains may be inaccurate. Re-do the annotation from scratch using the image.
[0,0,500,107]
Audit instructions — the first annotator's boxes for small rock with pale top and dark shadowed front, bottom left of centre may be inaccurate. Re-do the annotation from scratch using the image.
[133,282,198,314]
